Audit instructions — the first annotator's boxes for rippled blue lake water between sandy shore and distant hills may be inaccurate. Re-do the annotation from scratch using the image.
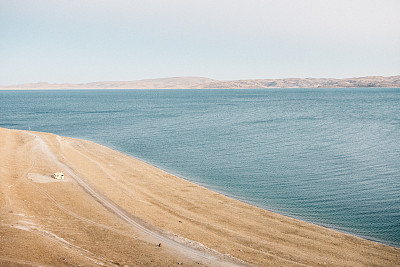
[0,88,400,247]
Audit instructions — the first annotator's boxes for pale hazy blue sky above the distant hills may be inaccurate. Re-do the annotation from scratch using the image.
[0,0,400,85]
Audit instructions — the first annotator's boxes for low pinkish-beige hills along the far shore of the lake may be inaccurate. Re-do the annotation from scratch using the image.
[0,75,400,90]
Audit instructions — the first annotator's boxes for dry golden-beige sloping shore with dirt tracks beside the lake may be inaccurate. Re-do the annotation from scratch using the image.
[0,128,400,266]
